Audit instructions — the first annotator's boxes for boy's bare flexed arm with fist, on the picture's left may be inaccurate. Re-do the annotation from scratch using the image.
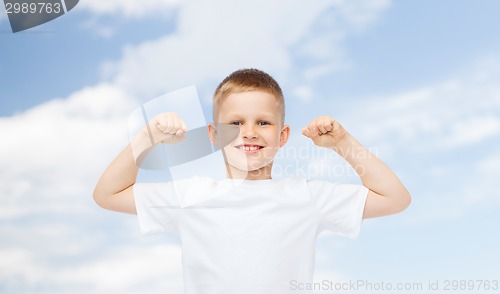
[93,112,186,214]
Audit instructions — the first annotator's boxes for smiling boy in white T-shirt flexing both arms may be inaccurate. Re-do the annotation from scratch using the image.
[94,69,410,294]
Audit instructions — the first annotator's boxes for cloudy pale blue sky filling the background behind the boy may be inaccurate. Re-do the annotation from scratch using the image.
[0,0,500,293]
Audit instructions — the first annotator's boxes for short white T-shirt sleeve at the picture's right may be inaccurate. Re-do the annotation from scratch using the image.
[308,181,368,239]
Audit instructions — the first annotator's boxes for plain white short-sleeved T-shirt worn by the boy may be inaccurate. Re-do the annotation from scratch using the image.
[134,177,368,294]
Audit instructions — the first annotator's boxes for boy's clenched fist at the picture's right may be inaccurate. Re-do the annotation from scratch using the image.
[302,116,347,148]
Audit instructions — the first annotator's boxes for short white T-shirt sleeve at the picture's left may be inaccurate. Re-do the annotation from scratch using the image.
[134,182,186,234]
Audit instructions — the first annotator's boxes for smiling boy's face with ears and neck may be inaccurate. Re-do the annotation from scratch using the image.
[209,91,290,179]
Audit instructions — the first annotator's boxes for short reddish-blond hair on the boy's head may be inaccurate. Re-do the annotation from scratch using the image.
[213,68,285,125]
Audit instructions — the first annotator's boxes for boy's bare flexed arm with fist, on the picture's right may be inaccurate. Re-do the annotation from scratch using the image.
[302,116,411,218]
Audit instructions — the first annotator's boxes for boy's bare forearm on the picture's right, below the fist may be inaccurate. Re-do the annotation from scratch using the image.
[332,134,409,200]
